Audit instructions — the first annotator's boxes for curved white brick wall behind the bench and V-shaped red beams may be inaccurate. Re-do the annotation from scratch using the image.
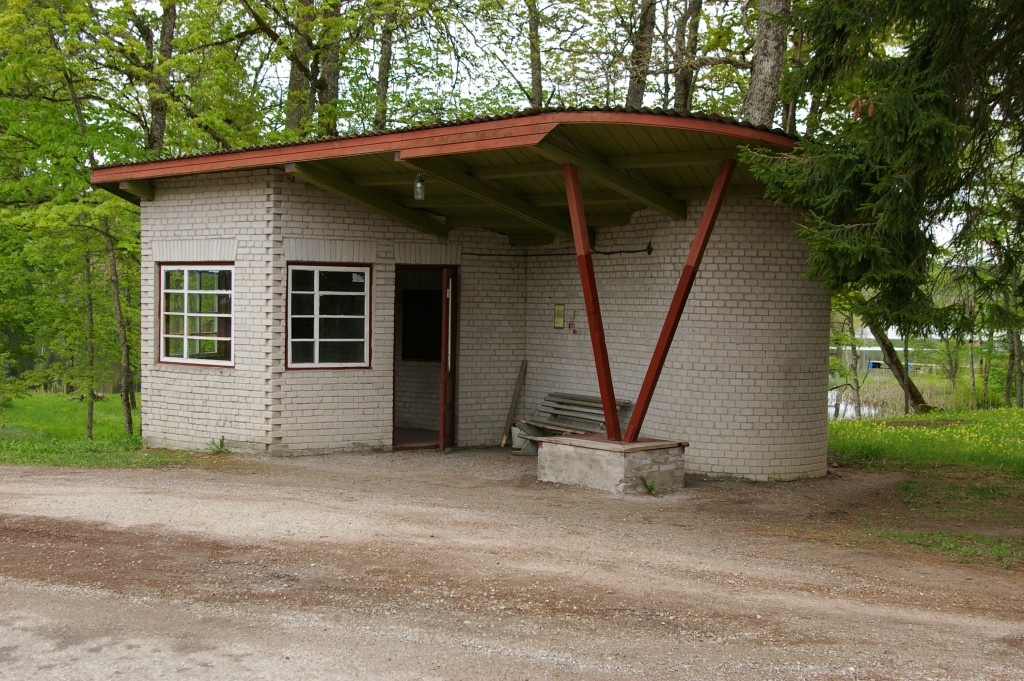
[526,200,828,479]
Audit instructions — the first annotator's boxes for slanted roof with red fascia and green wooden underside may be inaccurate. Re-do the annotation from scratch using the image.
[91,111,795,244]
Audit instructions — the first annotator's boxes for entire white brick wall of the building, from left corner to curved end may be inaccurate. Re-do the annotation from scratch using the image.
[136,171,828,479]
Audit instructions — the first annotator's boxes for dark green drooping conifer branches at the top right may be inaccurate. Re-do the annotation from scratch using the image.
[746,0,1024,330]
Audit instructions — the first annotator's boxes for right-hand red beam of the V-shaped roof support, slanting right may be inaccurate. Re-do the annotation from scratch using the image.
[622,159,736,442]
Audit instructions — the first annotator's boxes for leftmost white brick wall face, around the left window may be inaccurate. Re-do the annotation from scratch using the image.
[141,171,273,452]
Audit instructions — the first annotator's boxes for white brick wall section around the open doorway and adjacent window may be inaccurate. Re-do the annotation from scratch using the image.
[271,171,525,453]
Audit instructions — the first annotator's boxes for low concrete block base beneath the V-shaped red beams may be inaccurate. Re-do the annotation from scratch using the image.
[537,435,688,494]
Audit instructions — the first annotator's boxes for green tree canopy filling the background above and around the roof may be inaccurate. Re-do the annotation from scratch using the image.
[0,0,1024,426]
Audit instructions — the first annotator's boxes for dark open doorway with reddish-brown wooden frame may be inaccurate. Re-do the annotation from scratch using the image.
[393,266,457,450]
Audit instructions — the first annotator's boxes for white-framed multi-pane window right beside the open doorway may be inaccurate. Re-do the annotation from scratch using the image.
[288,265,370,369]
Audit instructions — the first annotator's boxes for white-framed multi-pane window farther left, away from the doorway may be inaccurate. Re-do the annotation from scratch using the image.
[160,264,234,366]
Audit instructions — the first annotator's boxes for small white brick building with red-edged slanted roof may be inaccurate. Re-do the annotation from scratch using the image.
[93,112,828,479]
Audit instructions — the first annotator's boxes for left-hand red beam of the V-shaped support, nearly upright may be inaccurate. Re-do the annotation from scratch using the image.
[562,163,622,441]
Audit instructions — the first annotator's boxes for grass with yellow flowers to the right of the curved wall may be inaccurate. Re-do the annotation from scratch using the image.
[828,409,1024,568]
